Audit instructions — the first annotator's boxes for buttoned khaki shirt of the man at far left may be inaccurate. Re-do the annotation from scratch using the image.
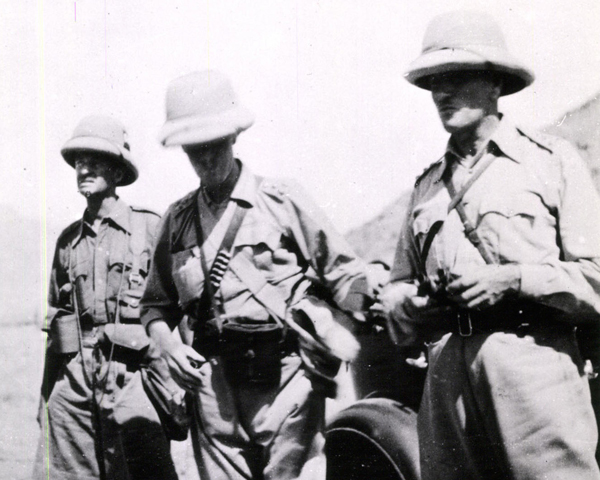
[48,199,159,325]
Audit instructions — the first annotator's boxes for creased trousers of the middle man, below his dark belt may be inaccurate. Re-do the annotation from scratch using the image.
[189,354,325,480]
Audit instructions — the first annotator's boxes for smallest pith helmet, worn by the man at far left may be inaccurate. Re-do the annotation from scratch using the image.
[60,115,139,186]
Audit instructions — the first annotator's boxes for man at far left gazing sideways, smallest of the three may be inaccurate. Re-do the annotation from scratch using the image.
[34,116,177,480]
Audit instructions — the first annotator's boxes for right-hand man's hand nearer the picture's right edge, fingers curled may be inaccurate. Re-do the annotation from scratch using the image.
[446,265,521,310]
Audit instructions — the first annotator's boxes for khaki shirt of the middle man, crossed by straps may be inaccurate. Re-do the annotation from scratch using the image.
[142,164,367,328]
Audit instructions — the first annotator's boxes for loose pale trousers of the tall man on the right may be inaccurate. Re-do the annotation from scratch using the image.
[419,329,600,480]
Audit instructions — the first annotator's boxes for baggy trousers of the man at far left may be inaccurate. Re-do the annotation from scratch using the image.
[33,346,177,480]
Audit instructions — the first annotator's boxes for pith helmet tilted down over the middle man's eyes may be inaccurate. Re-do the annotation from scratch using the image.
[159,70,254,147]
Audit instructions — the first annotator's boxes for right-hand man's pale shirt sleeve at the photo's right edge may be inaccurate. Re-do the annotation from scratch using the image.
[520,143,600,321]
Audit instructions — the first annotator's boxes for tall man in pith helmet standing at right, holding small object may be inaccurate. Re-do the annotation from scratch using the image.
[381,12,600,480]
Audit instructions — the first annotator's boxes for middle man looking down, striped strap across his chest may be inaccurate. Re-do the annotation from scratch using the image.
[142,71,368,480]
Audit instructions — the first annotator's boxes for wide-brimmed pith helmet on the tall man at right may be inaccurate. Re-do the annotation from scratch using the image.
[404,11,534,95]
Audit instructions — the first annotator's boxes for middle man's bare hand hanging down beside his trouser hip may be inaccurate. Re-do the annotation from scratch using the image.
[148,320,206,393]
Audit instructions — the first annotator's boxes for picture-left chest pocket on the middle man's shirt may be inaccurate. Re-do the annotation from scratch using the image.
[172,246,204,308]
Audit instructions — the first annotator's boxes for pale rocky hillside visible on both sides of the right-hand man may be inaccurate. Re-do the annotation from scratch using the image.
[346,92,600,264]
